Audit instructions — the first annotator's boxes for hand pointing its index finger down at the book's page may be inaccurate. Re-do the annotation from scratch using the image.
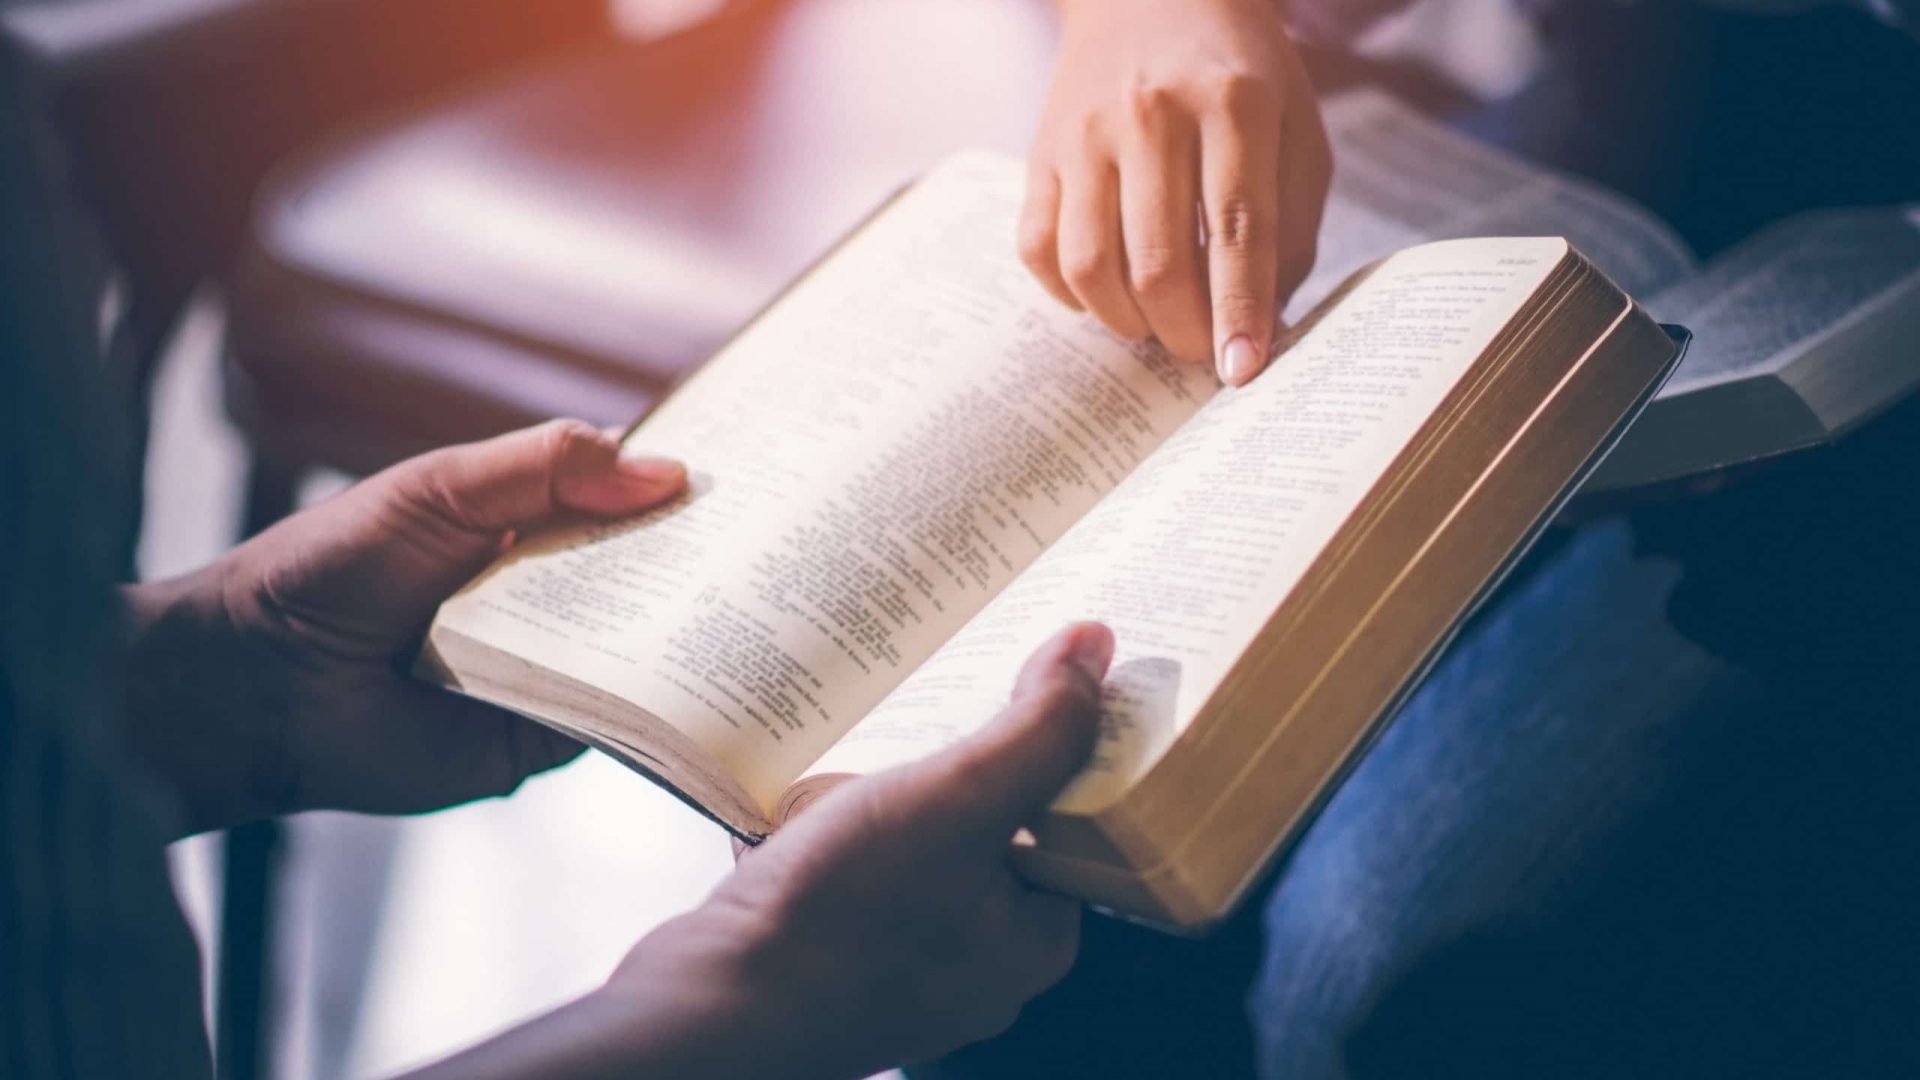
[1020,0,1332,386]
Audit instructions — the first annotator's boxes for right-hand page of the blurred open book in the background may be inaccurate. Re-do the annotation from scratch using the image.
[1645,206,1920,398]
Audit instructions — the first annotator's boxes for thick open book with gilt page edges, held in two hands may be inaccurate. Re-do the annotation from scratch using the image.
[420,148,1678,926]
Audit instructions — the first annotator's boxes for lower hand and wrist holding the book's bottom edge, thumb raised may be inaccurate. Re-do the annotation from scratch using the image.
[415,623,1114,1080]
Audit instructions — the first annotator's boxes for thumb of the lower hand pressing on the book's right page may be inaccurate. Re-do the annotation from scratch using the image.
[908,623,1114,846]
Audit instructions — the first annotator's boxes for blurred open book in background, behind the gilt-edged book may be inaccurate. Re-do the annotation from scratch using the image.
[1288,90,1920,490]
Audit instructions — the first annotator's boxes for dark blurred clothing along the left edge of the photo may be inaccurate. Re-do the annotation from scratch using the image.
[0,23,209,1080]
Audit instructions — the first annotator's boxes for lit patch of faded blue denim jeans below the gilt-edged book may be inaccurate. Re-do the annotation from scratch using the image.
[1250,521,1749,1076]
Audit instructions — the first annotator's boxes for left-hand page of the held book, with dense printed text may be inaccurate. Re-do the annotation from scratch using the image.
[440,156,1217,809]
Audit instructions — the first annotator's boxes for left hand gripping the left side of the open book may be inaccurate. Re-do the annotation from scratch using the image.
[127,421,685,830]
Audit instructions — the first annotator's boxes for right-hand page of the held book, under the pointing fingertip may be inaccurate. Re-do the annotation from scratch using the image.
[810,238,1567,813]
